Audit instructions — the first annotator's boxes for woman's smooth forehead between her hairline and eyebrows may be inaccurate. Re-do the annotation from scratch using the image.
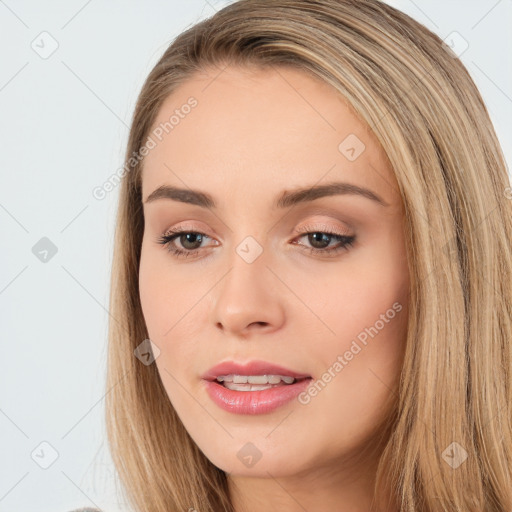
[142,67,397,208]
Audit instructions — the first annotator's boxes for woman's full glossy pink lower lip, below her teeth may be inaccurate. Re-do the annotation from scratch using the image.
[205,378,312,414]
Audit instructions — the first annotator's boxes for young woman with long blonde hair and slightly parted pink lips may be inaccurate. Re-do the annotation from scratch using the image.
[106,0,512,512]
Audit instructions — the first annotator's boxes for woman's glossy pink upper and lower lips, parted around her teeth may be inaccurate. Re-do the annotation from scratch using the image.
[201,361,312,414]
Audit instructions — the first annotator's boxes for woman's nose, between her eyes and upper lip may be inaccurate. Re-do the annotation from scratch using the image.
[212,247,285,337]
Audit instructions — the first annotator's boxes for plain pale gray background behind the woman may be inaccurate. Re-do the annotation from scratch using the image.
[0,0,512,512]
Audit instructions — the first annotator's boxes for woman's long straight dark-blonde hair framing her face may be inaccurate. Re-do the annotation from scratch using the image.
[106,0,512,512]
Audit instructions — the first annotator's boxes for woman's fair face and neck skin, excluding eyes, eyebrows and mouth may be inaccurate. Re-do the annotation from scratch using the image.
[139,66,409,512]
